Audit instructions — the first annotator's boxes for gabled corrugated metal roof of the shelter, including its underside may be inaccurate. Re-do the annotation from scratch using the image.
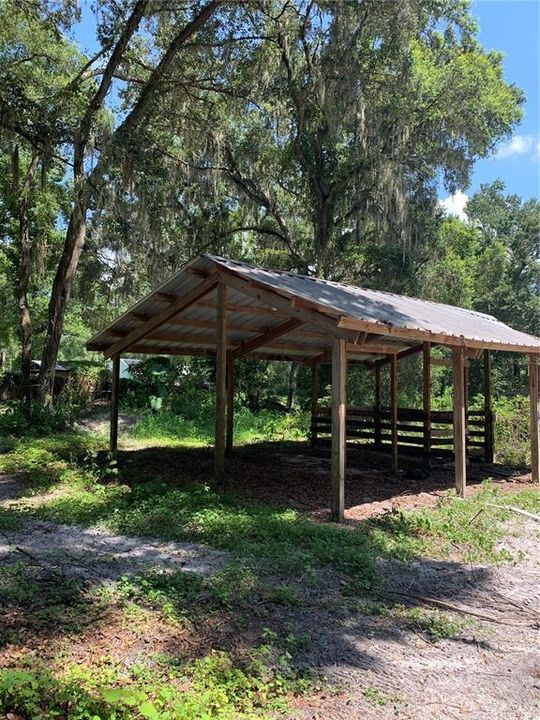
[87,253,540,361]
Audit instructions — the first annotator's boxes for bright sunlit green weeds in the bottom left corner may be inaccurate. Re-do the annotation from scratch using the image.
[0,646,309,720]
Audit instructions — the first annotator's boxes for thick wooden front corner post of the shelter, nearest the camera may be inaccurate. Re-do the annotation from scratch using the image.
[332,339,347,522]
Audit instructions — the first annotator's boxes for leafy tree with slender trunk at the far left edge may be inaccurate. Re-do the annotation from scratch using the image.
[0,3,81,404]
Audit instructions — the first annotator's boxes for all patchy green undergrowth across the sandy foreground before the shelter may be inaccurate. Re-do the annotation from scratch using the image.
[0,434,540,720]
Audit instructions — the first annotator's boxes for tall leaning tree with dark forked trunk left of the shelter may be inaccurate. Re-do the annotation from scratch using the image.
[3,0,220,403]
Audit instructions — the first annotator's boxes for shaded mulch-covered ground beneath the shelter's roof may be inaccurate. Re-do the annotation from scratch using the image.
[118,442,537,522]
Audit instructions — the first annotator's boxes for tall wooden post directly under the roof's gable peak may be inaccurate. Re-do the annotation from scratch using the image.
[214,282,227,485]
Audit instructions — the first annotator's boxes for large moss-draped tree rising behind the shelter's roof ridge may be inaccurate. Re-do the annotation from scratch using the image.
[186,0,522,279]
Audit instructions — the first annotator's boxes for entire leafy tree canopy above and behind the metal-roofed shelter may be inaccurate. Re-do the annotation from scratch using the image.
[0,0,539,399]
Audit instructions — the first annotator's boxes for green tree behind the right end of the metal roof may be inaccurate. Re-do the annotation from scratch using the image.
[419,180,540,394]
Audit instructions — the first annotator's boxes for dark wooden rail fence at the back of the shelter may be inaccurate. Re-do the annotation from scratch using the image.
[311,407,494,462]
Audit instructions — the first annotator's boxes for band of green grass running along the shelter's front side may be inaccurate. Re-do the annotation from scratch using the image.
[0,428,540,588]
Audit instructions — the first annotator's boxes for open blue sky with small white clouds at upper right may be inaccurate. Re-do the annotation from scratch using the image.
[445,0,540,214]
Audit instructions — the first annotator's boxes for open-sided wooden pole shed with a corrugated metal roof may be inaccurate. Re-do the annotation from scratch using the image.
[87,253,540,521]
